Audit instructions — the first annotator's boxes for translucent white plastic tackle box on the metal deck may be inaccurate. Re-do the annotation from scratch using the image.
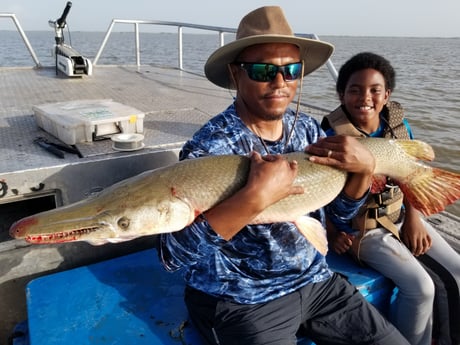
[32,99,145,145]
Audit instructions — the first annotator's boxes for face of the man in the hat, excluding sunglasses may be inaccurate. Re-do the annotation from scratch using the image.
[232,43,300,120]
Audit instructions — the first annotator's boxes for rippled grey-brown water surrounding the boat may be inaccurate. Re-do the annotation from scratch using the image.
[0,29,460,215]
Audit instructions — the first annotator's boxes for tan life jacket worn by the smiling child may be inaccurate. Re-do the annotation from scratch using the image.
[322,101,410,239]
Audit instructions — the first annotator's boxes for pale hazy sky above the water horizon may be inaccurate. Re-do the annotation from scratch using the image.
[0,0,460,37]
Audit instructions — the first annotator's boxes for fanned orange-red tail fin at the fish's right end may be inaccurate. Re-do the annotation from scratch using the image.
[398,168,460,216]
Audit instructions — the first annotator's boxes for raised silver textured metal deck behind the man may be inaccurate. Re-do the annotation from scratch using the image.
[0,66,231,174]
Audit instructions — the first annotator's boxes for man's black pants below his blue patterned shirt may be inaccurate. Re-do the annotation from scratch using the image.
[185,274,409,345]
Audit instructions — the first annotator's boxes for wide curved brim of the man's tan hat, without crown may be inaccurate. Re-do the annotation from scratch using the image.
[204,35,334,89]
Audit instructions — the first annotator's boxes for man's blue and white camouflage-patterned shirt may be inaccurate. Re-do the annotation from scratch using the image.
[159,104,366,304]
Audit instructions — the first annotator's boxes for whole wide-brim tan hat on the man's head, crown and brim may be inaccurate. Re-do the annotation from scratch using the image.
[204,6,334,89]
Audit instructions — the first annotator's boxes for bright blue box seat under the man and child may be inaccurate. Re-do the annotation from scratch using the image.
[22,249,393,345]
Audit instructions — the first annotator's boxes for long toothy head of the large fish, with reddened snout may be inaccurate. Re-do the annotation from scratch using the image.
[10,175,195,245]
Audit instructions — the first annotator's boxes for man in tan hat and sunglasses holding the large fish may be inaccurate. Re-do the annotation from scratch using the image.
[159,6,408,345]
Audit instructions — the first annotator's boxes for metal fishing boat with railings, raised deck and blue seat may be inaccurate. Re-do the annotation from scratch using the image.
[0,8,460,345]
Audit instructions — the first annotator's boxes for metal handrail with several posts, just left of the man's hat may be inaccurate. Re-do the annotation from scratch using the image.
[93,19,236,70]
